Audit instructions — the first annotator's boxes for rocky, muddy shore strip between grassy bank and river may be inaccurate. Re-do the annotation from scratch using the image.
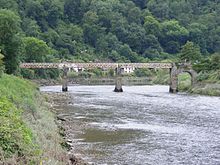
[42,92,91,165]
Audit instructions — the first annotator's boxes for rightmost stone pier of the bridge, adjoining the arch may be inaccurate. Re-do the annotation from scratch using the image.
[170,64,178,93]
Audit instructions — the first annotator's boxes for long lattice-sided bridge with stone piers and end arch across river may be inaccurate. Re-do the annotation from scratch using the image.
[20,63,197,93]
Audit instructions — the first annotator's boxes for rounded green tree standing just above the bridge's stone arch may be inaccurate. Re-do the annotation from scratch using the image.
[180,41,201,62]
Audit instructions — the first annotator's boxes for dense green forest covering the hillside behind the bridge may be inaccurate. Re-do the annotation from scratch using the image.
[0,0,220,78]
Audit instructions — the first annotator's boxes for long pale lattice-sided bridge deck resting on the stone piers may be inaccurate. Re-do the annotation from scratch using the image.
[20,63,172,69]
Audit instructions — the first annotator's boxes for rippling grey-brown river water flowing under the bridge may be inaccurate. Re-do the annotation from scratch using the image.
[41,86,220,165]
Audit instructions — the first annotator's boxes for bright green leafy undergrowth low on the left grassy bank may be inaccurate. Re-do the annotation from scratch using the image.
[0,98,33,160]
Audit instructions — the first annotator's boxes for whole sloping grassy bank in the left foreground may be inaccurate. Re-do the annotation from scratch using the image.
[0,74,67,165]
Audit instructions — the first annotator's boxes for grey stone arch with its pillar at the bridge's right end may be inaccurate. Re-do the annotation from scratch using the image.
[170,65,197,93]
